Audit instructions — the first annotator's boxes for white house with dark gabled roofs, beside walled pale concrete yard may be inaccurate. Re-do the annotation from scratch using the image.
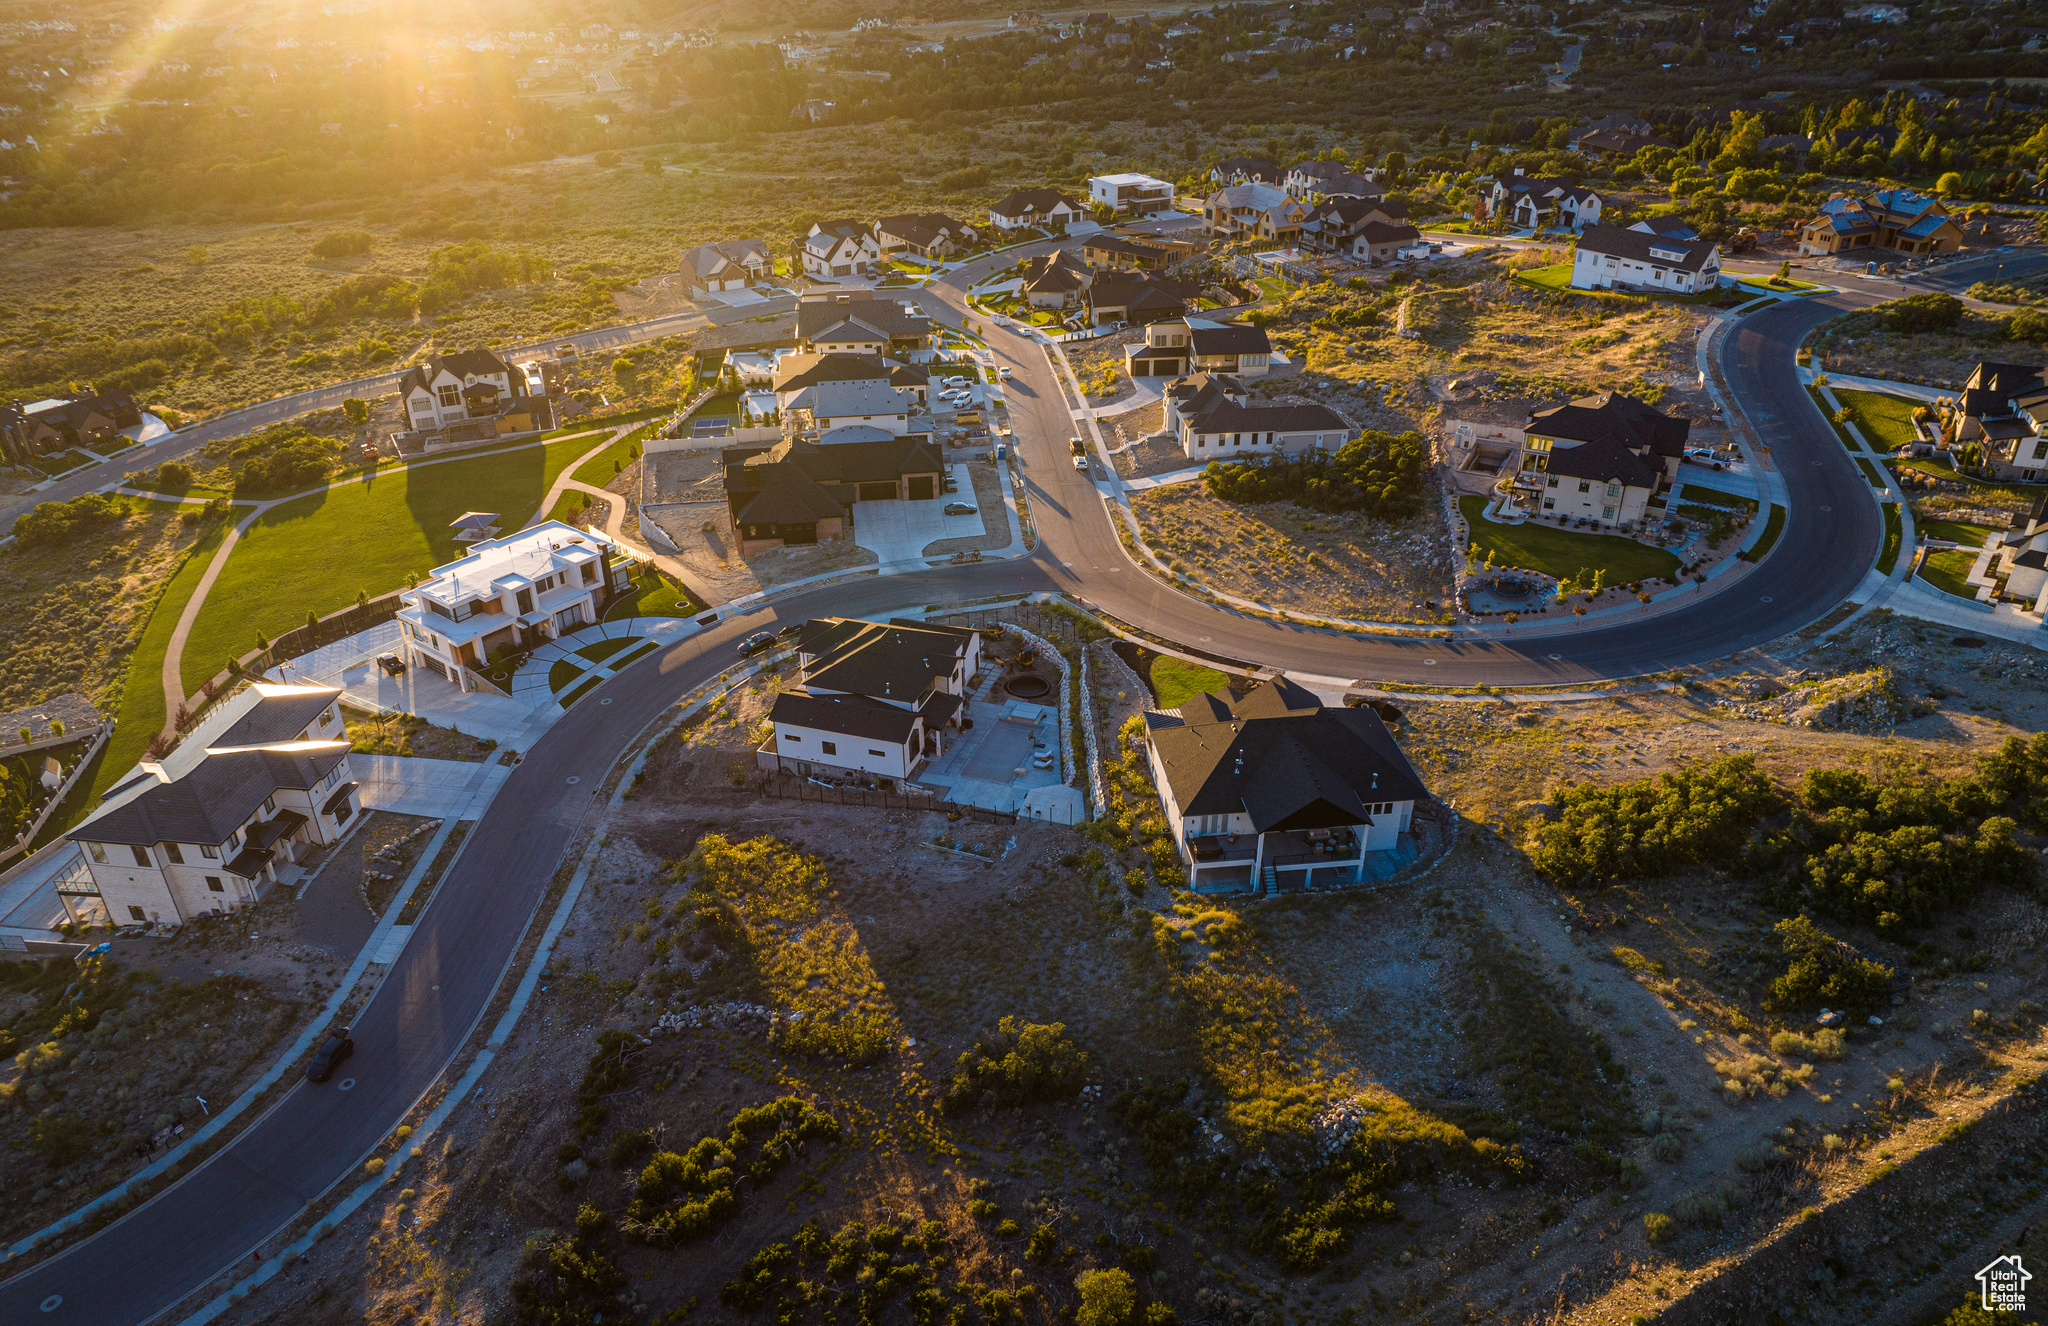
[756,617,981,781]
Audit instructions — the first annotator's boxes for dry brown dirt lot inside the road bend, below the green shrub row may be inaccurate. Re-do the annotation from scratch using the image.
[1130,482,1452,621]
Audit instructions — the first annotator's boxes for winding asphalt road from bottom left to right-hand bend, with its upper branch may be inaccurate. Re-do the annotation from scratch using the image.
[0,243,2048,1326]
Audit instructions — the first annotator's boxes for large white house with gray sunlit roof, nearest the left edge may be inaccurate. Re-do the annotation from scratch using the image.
[57,682,362,926]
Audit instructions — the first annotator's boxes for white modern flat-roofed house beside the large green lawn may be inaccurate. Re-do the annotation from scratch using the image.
[397,512,631,691]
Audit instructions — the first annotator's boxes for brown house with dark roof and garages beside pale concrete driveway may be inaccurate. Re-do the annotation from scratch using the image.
[721,432,946,557]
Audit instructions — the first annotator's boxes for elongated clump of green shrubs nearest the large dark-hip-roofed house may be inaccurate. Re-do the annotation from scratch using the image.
[1530,756,1782,881]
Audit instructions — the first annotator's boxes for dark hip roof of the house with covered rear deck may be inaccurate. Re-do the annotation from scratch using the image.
[1151,678,1430,832]
